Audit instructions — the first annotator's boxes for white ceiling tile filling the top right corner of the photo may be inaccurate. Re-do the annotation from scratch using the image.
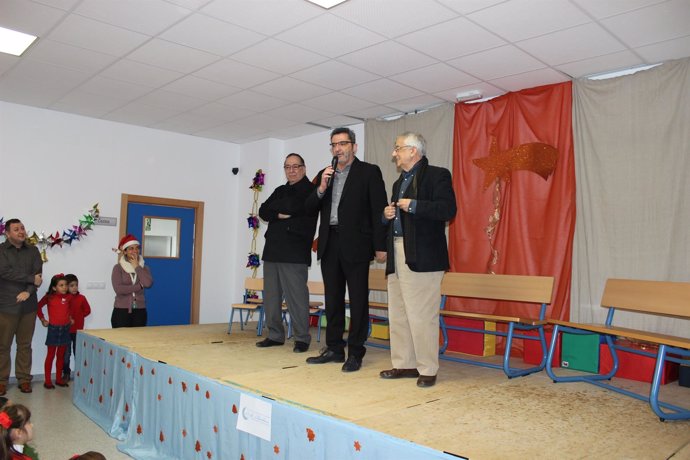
[601,0,690,48]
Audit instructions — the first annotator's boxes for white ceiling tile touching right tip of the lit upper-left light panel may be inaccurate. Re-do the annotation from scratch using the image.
[49,14,149,56]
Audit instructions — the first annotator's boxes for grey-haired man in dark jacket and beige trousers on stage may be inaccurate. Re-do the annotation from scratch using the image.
[379,132,457,387]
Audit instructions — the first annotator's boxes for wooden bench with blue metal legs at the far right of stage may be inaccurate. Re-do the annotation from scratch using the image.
[546,279,690,421]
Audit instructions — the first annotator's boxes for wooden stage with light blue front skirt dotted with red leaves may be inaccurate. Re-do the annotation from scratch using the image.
[74,323,690,460]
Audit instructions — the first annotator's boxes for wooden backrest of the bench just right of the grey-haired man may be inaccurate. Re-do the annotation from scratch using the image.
[441,272,553,304]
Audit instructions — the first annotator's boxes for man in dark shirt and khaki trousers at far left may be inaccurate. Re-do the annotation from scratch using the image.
[0,219,43,396]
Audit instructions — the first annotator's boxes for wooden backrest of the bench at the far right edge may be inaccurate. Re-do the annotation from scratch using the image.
[601,279,690,319]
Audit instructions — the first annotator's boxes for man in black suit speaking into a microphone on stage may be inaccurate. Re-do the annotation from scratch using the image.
[306,128,386,372]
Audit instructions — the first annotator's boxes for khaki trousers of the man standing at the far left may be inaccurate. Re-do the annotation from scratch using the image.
[0,311,36,385]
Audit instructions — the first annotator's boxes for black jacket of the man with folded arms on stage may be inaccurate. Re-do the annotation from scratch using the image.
[259,176,316,265]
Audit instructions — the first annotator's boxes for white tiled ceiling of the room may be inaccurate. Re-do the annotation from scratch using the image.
[0,0,690,144]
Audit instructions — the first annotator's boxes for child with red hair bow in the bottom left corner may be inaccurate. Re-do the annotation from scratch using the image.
[0,404,38,460]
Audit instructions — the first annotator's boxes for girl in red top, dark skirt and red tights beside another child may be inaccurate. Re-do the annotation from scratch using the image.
[38,273,72,390]
